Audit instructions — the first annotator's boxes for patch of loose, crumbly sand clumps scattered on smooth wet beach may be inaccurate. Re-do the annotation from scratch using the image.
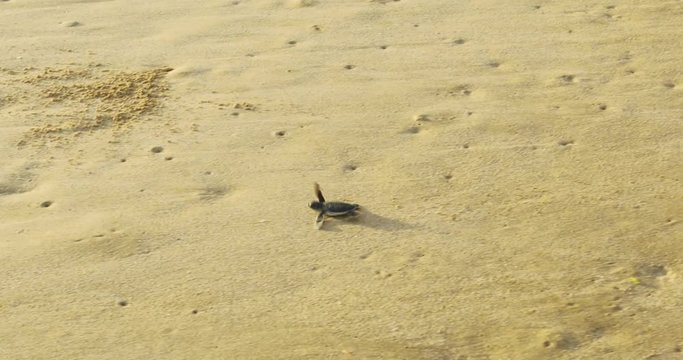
[4,65,172,146]
